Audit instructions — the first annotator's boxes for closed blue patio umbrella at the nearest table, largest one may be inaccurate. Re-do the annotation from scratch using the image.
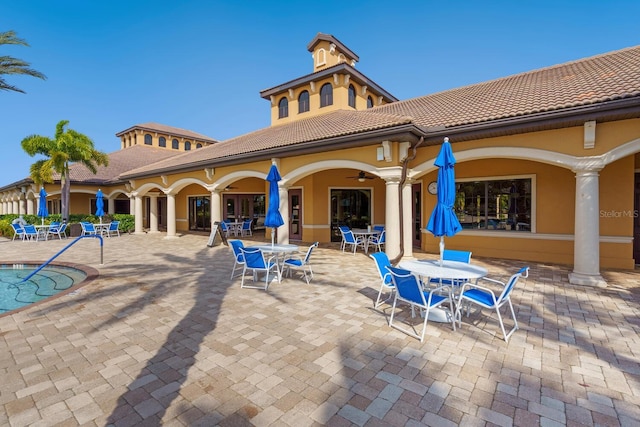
[427,138,462,264]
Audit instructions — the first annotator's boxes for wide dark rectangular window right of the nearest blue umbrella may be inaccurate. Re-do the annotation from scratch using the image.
[454,178,531,232]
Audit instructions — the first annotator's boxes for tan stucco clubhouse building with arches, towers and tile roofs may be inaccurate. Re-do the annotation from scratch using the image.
[0,34,640,284]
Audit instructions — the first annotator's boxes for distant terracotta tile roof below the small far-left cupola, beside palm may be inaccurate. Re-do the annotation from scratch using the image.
[59,145,182,184]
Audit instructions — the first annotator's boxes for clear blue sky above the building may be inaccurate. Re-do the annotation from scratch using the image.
[0,0,640,187]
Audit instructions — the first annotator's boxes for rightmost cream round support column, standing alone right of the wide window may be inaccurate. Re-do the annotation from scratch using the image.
[569,170,607,286]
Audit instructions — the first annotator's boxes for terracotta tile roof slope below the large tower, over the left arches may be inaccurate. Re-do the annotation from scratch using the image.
[123,110,411,176]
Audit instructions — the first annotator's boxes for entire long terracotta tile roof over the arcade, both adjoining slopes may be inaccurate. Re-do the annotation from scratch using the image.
[122,46,640,177]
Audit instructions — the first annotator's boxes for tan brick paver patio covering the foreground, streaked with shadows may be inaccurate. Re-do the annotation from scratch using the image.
[0,234,640,427]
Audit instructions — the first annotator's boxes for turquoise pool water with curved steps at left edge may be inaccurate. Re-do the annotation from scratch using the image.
[0,264,87,314]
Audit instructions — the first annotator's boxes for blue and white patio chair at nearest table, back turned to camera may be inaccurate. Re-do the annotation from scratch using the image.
[387,267,456,342]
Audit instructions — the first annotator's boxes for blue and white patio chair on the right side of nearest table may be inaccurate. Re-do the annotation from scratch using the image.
[456,267,529,342]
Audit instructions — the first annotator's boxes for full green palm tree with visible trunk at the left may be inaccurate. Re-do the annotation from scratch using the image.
[21,120,109,221]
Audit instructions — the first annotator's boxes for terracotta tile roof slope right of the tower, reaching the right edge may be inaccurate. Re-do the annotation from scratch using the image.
[374,46,640,127]
